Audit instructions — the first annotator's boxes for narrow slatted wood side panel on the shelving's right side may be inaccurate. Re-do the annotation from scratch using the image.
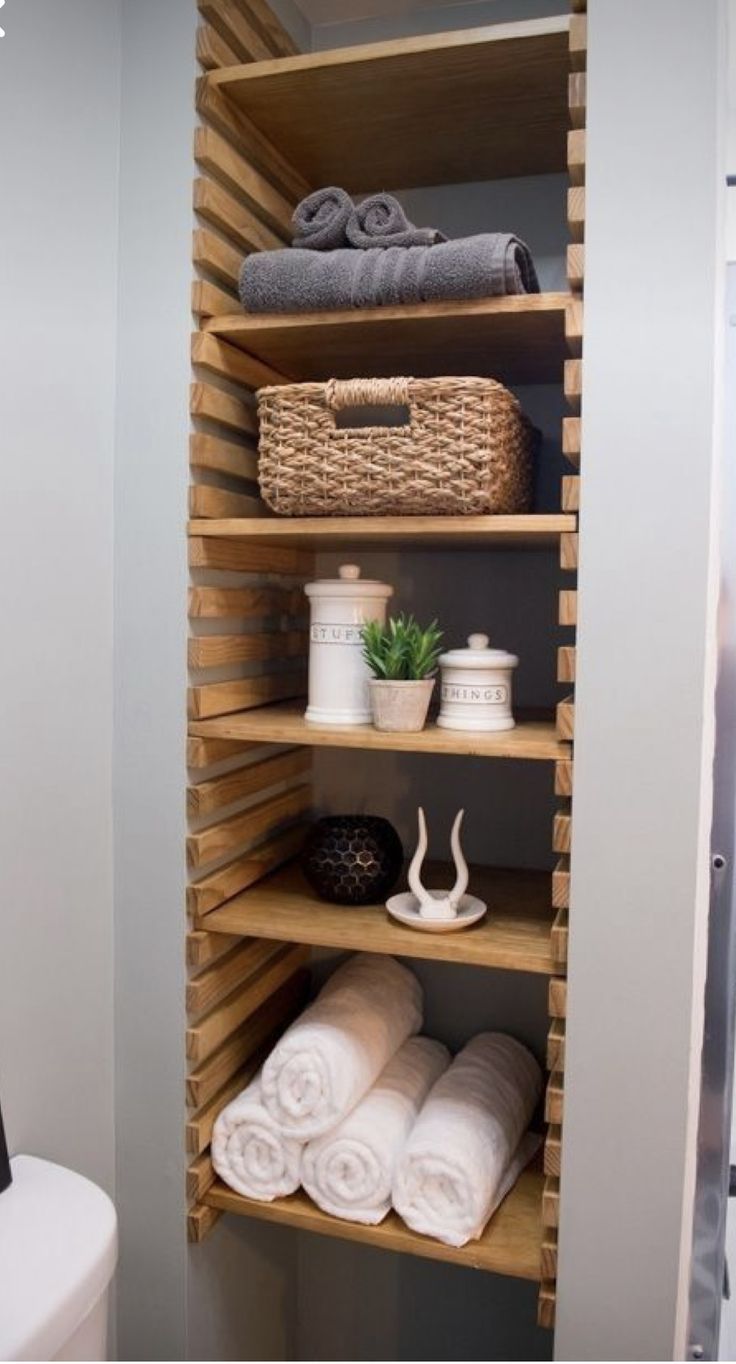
[537,8,587,1327]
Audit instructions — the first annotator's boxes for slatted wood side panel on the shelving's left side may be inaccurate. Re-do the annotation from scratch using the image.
[185,0,313,1241]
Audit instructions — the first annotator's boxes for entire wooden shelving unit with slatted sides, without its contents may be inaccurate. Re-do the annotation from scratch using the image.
[187,0,586,1326]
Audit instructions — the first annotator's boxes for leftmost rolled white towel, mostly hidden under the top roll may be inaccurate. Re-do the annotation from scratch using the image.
[213,1071,301,1203]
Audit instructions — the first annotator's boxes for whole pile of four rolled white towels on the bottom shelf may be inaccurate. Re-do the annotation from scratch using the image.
[213,953,541,1245]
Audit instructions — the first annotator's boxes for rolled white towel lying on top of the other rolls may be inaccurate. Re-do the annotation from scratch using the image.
[263,952,423,1142]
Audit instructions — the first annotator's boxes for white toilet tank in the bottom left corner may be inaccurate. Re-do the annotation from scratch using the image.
[0,1155,117,1360]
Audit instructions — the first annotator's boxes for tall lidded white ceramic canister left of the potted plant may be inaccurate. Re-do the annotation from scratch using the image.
[304,563,394,724]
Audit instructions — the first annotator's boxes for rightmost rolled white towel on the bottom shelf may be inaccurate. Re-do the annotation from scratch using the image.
[393,1033,542,1245]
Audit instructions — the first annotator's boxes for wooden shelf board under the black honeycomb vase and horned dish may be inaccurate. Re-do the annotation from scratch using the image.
[196,866,560,975]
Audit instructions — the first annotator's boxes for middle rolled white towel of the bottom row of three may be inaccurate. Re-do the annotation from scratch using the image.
[301,1037,450,1226]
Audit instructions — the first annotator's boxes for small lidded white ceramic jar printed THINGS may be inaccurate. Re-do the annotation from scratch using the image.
[438,634,519,732]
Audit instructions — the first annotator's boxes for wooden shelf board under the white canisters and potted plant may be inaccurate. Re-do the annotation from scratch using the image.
[189,701,570,761]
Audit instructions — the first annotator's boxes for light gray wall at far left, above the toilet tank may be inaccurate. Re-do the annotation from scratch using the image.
[0,0,120,1192]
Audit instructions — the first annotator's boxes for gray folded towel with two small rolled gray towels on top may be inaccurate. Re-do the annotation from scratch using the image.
[240,186,540,312]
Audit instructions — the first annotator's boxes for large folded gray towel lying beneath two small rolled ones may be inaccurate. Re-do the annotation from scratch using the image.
[240,232,540,312]
